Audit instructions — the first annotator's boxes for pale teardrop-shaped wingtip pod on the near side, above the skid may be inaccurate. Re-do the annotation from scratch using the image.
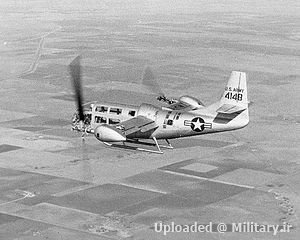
[94,124,126,142]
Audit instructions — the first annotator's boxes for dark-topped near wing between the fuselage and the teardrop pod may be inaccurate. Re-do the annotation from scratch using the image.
[116,116,158,137]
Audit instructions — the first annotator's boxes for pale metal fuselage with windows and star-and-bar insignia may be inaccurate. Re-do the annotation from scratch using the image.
[80,103,249,139]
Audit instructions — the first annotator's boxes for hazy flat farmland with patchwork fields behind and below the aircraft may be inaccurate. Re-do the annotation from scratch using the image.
[0,0,300,240]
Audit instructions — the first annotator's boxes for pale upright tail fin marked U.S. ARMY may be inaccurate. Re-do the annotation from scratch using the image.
[217,71,248,113]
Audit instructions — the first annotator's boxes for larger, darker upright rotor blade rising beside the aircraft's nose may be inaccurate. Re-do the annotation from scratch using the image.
[69,56,84,121]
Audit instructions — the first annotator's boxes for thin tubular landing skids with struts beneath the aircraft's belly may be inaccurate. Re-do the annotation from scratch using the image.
[103,137,173,154]
